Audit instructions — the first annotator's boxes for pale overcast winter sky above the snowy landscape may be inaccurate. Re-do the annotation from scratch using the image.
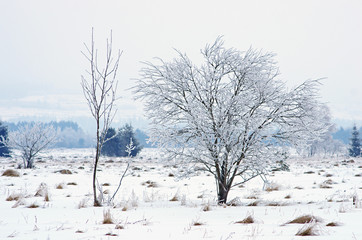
[0,0,362,127]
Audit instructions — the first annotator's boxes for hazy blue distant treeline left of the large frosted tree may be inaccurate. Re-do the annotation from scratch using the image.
[4,121,152,148]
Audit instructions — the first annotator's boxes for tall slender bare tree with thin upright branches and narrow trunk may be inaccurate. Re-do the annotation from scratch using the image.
[81,29,121,206]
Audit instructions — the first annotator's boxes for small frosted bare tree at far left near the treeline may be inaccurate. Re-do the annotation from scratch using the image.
[1,122,57,168]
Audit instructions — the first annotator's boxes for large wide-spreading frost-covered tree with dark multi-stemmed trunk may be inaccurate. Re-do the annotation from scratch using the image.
[135,38,327,203]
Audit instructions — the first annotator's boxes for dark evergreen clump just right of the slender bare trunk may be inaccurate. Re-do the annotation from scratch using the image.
[101,124,142,157]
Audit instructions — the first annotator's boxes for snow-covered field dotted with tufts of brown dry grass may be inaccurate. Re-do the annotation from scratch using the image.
[0,149,362,240]
